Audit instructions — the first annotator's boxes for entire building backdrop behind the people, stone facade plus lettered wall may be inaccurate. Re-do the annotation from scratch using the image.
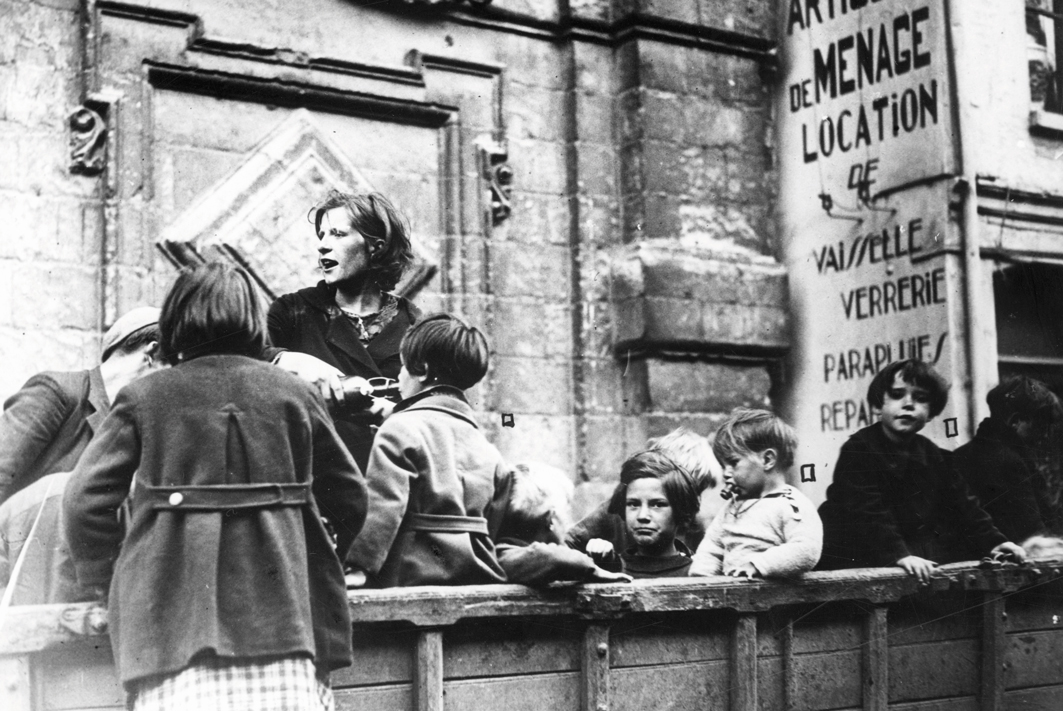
[0,0,1063,508]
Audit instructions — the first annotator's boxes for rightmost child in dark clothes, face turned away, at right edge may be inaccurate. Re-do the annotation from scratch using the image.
[955,376,1060,542]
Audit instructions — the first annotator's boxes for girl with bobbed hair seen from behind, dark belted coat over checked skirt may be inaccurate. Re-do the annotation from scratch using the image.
[64,264,366,711]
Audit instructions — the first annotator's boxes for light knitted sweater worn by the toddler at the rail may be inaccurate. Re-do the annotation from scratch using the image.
[690,486,823,577]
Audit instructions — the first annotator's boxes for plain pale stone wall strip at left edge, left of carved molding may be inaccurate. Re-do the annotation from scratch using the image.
[0,0,101,396]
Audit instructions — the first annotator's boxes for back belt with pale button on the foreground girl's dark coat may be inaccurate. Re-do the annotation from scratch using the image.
[134,483,310,511]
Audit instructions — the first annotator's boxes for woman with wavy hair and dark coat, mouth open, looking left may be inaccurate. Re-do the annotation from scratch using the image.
[269,190,420,470]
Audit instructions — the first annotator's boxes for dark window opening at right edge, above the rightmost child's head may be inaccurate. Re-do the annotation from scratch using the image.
[993,263,1063,395]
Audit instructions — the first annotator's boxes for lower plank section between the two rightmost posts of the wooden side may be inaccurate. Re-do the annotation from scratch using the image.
[889,640,981,702]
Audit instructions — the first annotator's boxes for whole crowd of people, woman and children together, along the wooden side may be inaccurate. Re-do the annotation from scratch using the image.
[0,192,1063,709]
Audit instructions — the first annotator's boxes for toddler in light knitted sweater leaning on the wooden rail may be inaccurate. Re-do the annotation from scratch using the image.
[690,408,823,578]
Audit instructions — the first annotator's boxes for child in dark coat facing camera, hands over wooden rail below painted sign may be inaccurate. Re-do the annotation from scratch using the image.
[820,359,1025,583]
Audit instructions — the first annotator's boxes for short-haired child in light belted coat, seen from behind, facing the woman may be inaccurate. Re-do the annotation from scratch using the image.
[347,314,506,588]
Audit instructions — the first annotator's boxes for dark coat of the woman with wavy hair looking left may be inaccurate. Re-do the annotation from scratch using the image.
[269,282,421,471]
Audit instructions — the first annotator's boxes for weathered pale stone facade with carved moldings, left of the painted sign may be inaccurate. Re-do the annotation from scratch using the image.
[0,0,789,510]
